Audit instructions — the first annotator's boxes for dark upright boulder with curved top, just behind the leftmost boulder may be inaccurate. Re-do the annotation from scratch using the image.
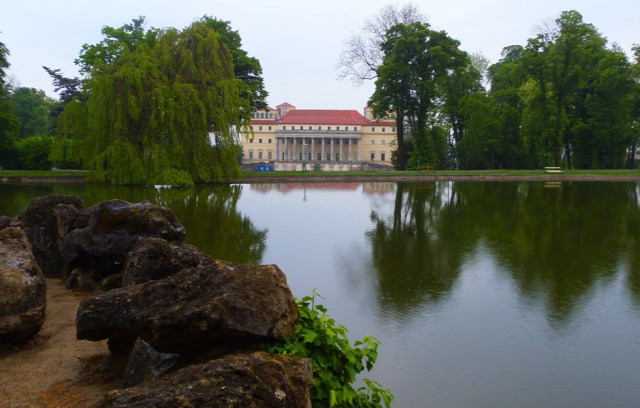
[18,194,84,278]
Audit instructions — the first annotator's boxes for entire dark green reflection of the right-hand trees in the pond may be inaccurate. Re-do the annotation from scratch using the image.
[367,182,640,326]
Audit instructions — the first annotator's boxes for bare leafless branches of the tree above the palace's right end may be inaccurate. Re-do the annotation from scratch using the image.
[337,3,428,85]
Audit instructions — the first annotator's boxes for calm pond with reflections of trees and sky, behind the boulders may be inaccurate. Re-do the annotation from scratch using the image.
[0,182,640,408]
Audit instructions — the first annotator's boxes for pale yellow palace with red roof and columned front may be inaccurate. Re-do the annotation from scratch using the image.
[241,103,396,170]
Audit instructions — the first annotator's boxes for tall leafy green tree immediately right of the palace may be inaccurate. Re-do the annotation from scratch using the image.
[370,22,479,166]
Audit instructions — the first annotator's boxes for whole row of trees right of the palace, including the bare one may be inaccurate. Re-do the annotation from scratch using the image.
[339,5,640,169]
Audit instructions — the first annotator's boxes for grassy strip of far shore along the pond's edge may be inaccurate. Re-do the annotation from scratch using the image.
[0,170,640,184]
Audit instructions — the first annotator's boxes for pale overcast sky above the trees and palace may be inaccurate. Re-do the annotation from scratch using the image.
[0,0,640,111]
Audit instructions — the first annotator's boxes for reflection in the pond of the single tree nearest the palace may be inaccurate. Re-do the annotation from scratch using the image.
[367,183,475,315]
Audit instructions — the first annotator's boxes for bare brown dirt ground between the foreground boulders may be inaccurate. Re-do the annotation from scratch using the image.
[0,279,126,408]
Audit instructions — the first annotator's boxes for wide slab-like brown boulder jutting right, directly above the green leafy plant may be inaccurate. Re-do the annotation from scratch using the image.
[76,260,298,354]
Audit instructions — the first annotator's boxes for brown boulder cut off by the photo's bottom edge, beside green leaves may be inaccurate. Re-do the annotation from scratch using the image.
[101,352,313,408]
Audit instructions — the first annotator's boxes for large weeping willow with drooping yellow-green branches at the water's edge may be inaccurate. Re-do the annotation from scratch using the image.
[58,19,251,184]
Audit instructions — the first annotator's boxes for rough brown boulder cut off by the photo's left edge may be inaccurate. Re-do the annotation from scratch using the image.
[0,227,47,343]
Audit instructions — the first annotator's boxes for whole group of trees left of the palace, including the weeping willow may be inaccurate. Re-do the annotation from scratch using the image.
[0,16,267,184]
